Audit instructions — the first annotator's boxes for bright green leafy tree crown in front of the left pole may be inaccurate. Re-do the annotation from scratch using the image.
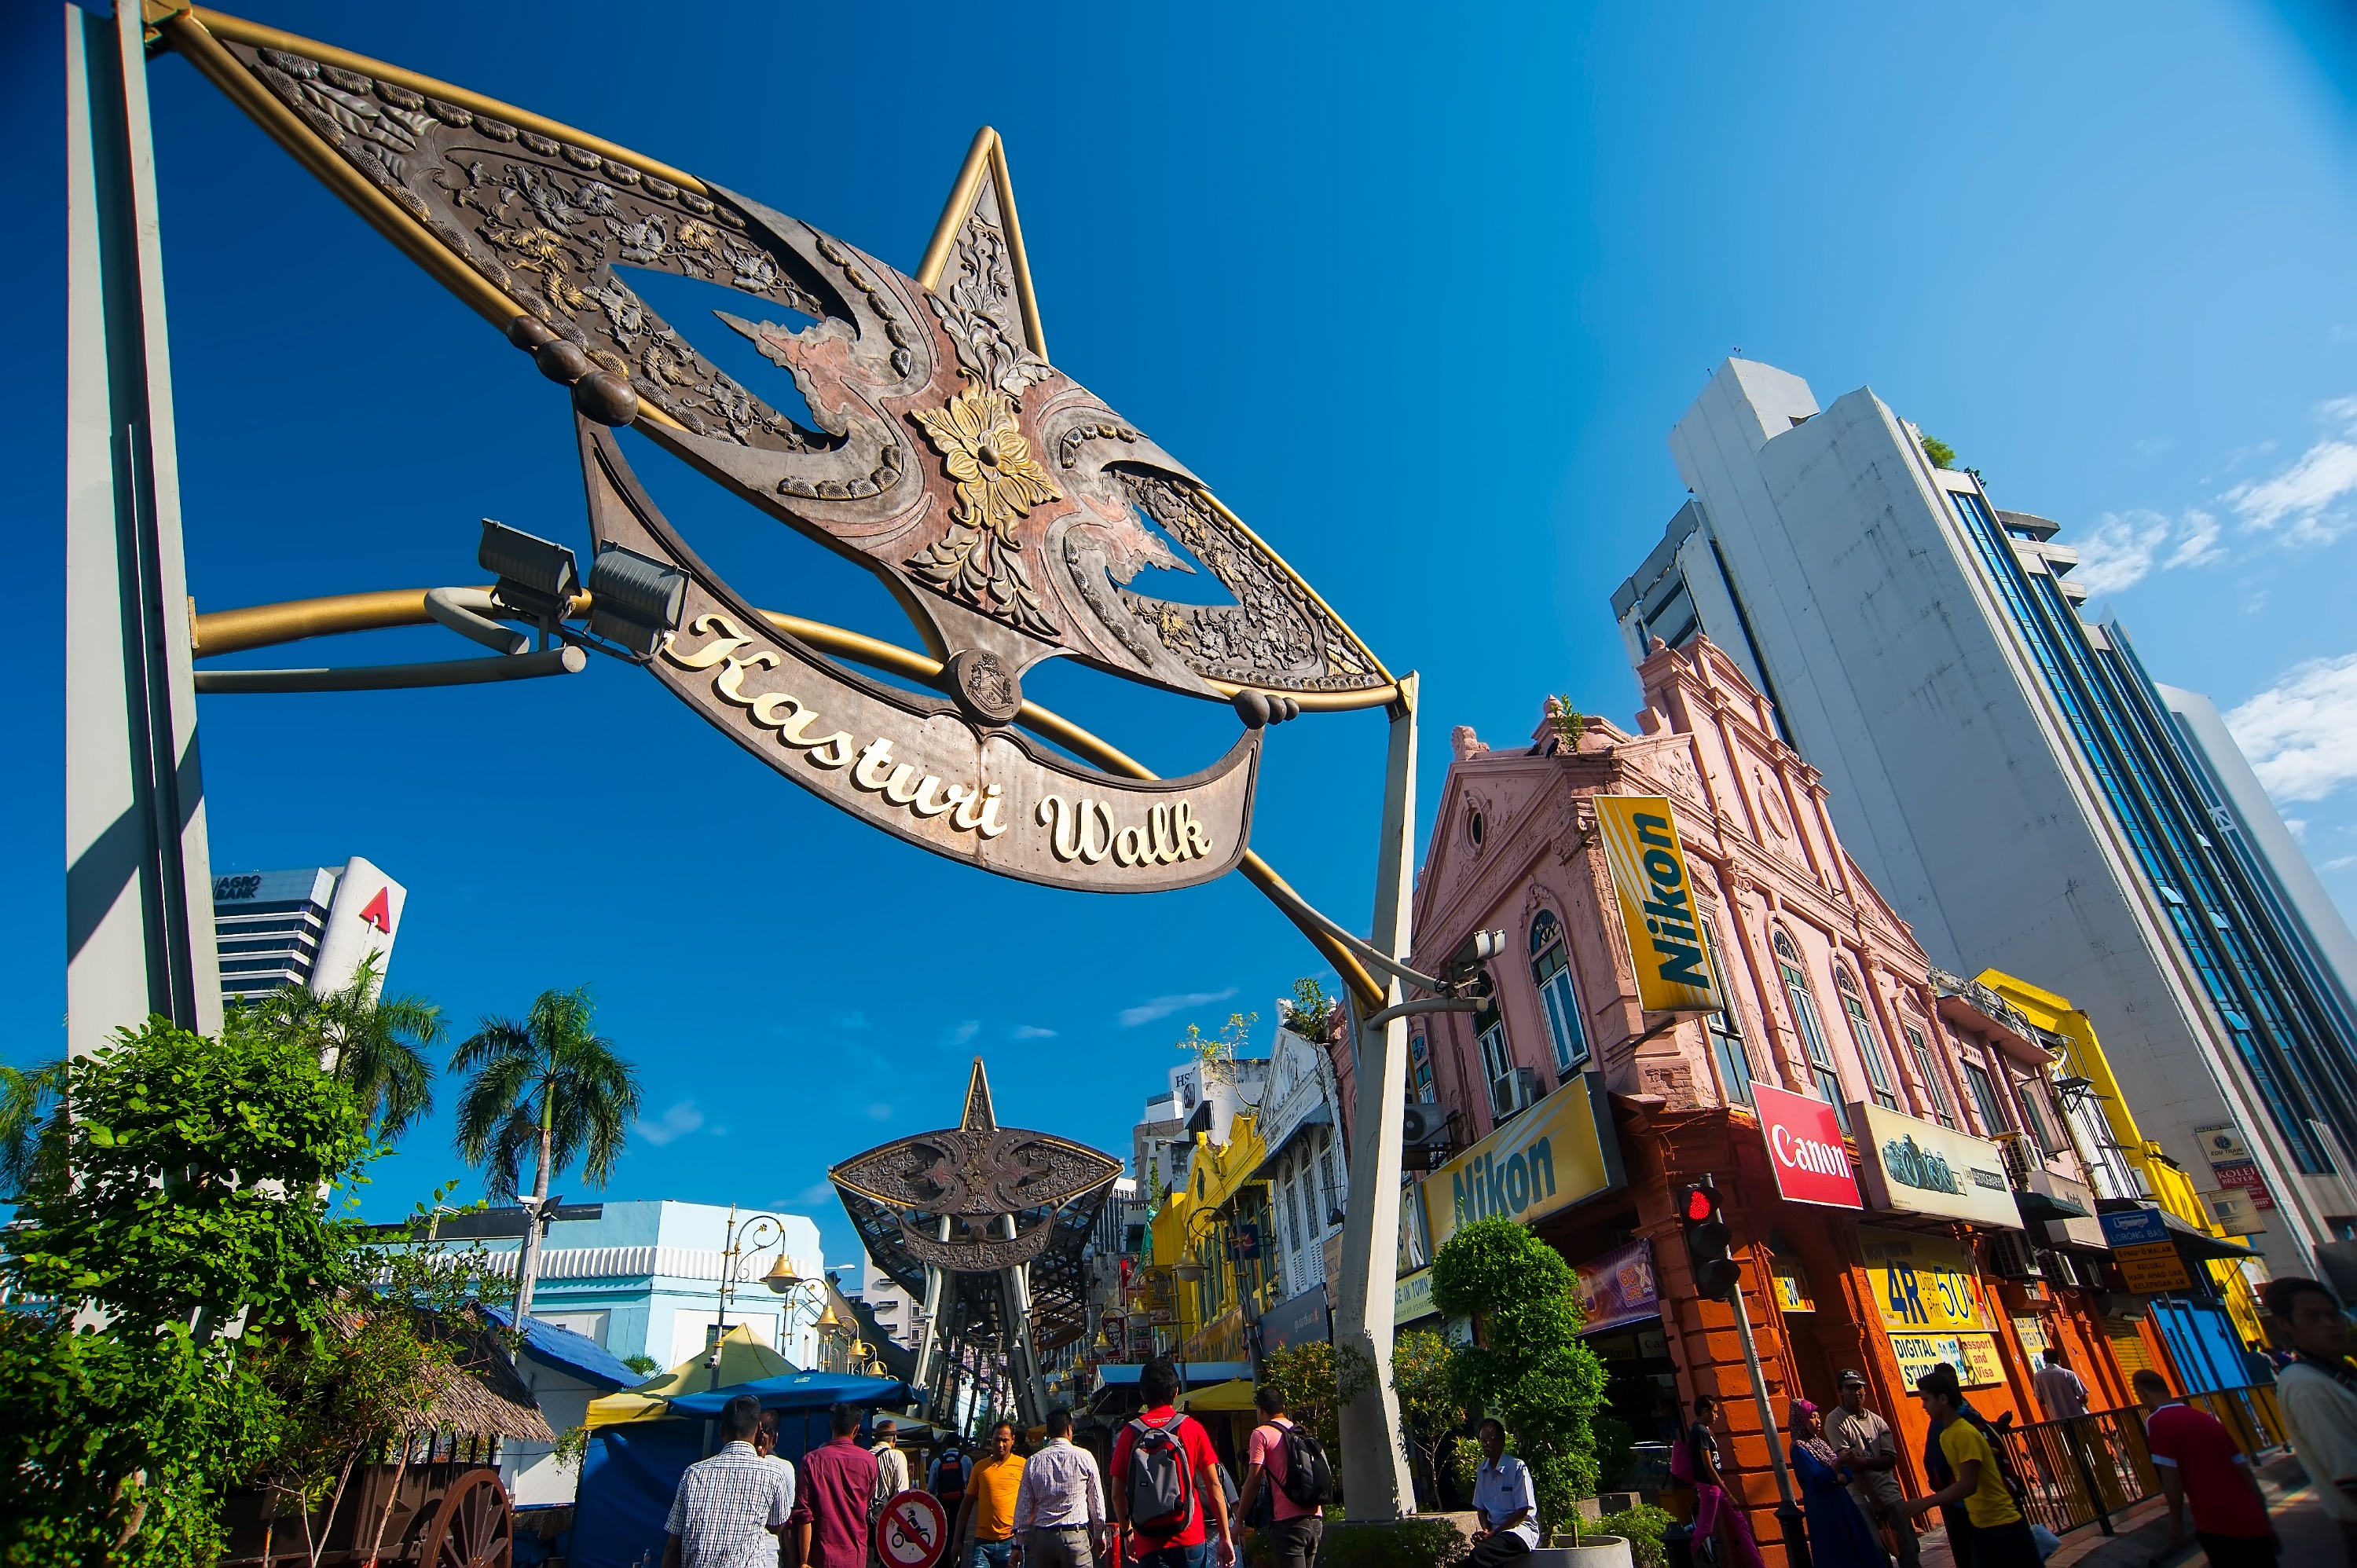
[5,1019,370,1337]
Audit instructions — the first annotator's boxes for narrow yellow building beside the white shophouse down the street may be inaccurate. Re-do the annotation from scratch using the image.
[1153,1111,1275,1361]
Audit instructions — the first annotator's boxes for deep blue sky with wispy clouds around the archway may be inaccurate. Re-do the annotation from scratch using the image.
[13,0,2357,1259]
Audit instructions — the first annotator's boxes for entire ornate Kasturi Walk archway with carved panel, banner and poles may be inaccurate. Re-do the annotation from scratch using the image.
[66,0,1499,1516]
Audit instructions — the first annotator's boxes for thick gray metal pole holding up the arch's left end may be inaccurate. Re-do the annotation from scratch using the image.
[66,2,222,1057]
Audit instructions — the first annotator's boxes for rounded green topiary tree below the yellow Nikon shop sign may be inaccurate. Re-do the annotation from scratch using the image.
[1433,1219,1605,1530]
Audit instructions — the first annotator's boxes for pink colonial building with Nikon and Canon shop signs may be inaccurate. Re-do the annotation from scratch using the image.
[1400,641,2128,1556]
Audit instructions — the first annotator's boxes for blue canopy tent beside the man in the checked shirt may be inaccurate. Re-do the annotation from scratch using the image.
[570,1372,907,1568]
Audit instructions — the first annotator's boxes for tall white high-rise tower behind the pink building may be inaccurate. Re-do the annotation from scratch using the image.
[1612,358,2357,1273]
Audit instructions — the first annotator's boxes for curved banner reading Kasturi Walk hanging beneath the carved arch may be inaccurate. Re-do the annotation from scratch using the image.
[582,427,1261,894]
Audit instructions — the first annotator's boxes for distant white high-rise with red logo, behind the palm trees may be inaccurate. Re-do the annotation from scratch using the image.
[212,856,410,1002]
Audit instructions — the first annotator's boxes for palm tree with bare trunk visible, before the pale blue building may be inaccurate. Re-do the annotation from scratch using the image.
[450,986,639,1325]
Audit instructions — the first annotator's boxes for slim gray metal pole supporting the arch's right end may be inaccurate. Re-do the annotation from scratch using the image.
[1334,672,1417,1519]
